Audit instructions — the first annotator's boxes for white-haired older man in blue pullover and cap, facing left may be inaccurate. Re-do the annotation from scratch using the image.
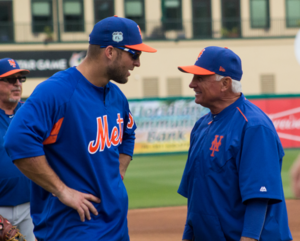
[178,46,292,241]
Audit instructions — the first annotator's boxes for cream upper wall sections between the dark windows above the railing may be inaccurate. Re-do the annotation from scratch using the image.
[9,0,298,42]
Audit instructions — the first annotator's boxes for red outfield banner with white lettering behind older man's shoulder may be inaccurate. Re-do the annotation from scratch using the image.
[249,97,300,148]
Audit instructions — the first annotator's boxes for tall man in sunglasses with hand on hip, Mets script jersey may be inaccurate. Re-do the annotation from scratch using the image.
[5,16,156,241]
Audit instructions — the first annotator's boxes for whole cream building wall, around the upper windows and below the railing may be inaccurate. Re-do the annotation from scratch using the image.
[0,0,300,98]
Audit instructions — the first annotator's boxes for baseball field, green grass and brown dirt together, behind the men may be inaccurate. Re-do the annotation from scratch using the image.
[125,149,300,241]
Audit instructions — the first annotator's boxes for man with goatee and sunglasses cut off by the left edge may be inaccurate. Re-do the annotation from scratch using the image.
[0,58,35,241]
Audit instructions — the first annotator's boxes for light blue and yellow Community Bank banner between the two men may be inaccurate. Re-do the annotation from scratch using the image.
[129,98,209,154]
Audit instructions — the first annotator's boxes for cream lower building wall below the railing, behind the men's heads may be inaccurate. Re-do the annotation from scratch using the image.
[0,39,300,98]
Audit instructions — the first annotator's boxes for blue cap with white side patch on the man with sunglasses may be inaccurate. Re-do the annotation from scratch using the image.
[89,15,157,53]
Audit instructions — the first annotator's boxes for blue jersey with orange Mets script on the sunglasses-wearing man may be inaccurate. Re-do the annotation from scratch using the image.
[5,67,136,241]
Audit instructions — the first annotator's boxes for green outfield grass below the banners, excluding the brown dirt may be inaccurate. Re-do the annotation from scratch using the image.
[124,149,300,209]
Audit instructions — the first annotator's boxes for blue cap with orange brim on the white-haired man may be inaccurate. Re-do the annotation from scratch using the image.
[178,46,243,81]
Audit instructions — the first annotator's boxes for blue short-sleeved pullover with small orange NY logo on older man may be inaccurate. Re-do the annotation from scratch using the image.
[178,94,292,241]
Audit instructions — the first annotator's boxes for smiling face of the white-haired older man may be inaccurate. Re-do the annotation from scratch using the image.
[189,75,222,108]
